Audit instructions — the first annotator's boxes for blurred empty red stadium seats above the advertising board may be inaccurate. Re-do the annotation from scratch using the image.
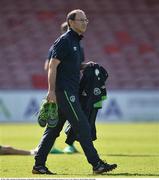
[0,0,159,90]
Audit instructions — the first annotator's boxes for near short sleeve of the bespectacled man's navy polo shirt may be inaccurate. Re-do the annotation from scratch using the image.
[51,38,68,61]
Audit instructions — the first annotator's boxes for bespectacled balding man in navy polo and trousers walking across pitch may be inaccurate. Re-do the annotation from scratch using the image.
[32,9,117,174]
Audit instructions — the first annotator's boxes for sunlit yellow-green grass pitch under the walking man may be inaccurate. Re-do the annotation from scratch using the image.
[0,123,159,178]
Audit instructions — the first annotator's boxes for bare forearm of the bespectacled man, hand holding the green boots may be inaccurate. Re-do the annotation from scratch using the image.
[47,59,60,102]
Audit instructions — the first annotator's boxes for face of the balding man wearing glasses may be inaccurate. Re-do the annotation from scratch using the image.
[70,12,88,34]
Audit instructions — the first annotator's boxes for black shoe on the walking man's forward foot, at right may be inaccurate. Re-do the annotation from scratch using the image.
[93,161,117,174]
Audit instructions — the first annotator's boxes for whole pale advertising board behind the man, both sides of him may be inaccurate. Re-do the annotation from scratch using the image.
[0,90,159,122]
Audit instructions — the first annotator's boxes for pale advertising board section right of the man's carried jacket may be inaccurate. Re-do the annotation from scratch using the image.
[98,91,159,121]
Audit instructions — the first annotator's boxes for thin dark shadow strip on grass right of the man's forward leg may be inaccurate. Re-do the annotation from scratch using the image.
[104,154,159,157]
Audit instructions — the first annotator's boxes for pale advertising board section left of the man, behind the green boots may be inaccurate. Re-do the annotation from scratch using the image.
[0,90,46,122]
